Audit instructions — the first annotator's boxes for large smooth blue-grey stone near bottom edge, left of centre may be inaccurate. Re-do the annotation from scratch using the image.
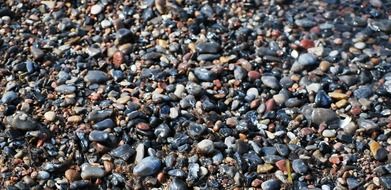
[133,156,161,176]
